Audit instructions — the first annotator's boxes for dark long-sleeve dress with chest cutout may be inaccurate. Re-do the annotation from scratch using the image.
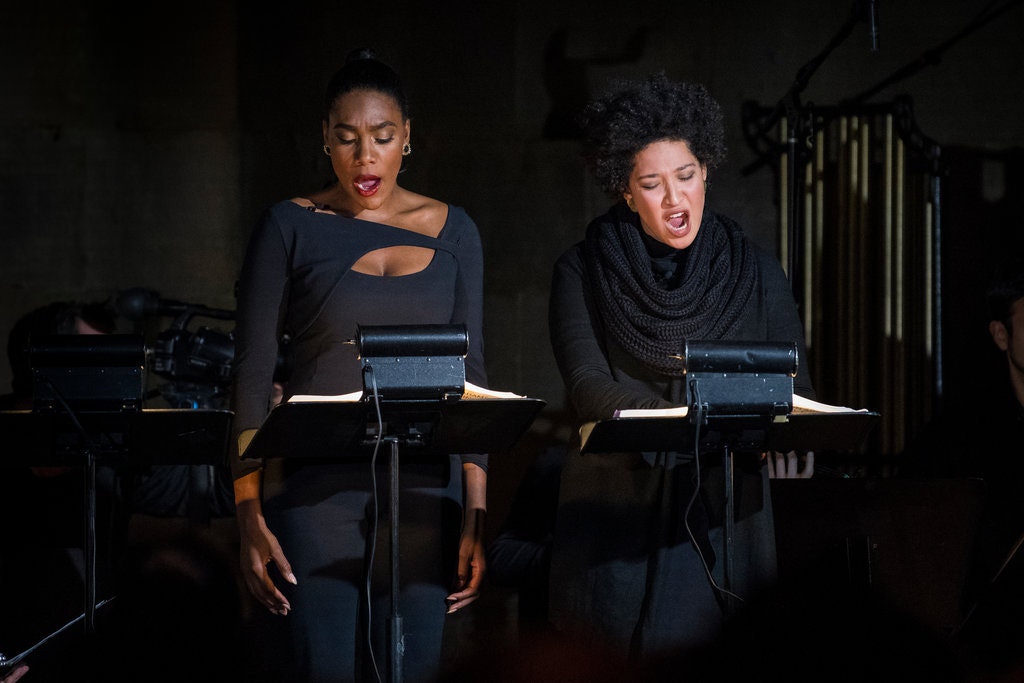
[232,201,486,681]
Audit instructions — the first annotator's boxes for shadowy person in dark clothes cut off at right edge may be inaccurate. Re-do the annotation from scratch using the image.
[900,254,1024,680]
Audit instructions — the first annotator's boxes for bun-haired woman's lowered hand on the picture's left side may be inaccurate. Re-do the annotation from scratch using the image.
[236,499,298,616]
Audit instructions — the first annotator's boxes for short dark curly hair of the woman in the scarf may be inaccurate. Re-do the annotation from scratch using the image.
[579,72,725,197]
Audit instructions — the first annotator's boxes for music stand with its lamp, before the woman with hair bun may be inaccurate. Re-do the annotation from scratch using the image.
[243,325,545,683]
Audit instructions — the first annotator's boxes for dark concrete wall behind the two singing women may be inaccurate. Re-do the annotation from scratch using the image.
[0,0,1024,483]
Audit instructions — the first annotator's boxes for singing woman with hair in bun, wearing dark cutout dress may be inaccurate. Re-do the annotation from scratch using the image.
[231,49,486,681]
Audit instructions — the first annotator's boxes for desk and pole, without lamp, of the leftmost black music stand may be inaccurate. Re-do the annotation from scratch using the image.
[0,409,232,636]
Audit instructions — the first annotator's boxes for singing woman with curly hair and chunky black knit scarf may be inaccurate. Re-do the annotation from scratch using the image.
[549,74,814,663]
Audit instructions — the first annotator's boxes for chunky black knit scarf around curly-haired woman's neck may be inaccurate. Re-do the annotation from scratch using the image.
[584,203,758,375]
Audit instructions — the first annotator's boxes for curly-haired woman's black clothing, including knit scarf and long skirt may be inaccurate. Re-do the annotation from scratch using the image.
[549,204,814,658]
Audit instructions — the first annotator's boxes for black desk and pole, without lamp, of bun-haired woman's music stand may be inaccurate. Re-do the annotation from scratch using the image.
[244,397,545,681]
